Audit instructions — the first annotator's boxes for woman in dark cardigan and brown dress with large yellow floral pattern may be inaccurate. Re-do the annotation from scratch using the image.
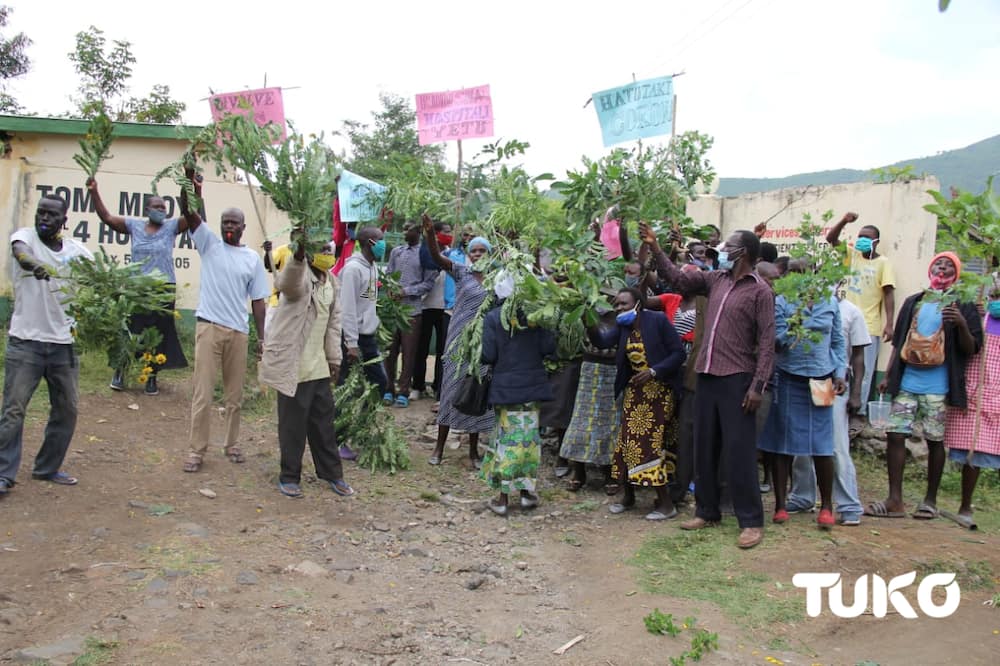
[589,287,684,520]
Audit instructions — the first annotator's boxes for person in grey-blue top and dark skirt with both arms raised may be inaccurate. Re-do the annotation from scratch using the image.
[87,172,190,395]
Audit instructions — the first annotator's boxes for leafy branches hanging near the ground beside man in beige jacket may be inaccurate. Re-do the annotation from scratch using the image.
[333,360,410,474]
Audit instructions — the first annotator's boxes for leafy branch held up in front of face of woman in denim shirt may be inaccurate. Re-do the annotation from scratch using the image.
[774,210,850,349]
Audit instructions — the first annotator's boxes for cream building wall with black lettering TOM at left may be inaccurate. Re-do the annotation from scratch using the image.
[0,117,289,309]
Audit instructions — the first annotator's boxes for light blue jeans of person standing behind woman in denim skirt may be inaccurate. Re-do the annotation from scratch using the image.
[787,392,862,517]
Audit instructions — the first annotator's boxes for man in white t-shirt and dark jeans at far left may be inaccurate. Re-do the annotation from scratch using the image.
[0,195,94,495]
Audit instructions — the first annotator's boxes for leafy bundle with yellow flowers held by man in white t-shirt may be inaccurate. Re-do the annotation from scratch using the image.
[61,247,173,376]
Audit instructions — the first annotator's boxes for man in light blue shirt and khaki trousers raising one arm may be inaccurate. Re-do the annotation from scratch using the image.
[181,193,271,472]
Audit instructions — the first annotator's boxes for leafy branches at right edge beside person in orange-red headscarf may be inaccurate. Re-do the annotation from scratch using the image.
[924,176,1000,307]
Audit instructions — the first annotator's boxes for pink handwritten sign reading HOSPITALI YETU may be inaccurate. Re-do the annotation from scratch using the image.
[417,86,493,146]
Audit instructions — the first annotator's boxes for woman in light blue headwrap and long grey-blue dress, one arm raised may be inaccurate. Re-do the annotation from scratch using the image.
[423,215,495,465]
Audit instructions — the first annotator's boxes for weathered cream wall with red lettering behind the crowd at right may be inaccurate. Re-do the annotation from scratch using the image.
[688,178,940,370]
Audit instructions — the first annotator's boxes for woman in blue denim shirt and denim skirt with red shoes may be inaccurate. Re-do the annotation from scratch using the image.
[757,264,847,529]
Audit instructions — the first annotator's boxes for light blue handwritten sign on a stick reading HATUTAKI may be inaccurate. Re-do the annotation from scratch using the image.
[592,76,674,146]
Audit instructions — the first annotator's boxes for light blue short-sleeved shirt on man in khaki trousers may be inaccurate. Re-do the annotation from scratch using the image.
[191,224,270,333]
